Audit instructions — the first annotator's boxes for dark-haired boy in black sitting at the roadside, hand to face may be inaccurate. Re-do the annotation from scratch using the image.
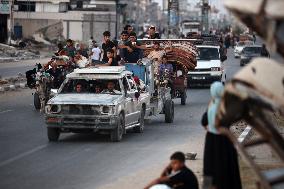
[145,152,198,189]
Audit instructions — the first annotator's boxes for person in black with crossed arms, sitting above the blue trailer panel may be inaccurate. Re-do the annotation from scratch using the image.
[122,32,145,63]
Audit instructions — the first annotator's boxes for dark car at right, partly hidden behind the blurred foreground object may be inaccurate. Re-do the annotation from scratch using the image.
[240,45,261,66]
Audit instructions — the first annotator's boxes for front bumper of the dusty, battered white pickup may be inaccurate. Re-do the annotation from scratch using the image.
[45,115,119,130]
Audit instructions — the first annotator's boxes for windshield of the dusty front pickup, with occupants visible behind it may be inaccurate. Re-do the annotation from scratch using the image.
[60,79,121,95]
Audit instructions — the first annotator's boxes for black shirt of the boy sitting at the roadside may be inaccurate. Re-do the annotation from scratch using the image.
[164,166,198,189]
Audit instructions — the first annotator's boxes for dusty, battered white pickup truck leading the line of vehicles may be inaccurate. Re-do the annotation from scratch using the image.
[45,66,150,141]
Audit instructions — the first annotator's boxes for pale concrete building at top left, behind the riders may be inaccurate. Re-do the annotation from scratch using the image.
[14,0,116,41]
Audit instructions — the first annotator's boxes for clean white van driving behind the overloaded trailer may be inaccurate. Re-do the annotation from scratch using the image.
[188,45,226,85]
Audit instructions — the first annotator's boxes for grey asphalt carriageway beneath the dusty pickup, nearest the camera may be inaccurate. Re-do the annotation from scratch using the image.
[0,49,242,189]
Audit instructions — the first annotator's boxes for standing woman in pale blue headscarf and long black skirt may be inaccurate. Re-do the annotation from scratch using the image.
[202,82,242,189]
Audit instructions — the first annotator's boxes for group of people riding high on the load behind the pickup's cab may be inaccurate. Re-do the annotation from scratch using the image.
[39,25,174,91]
